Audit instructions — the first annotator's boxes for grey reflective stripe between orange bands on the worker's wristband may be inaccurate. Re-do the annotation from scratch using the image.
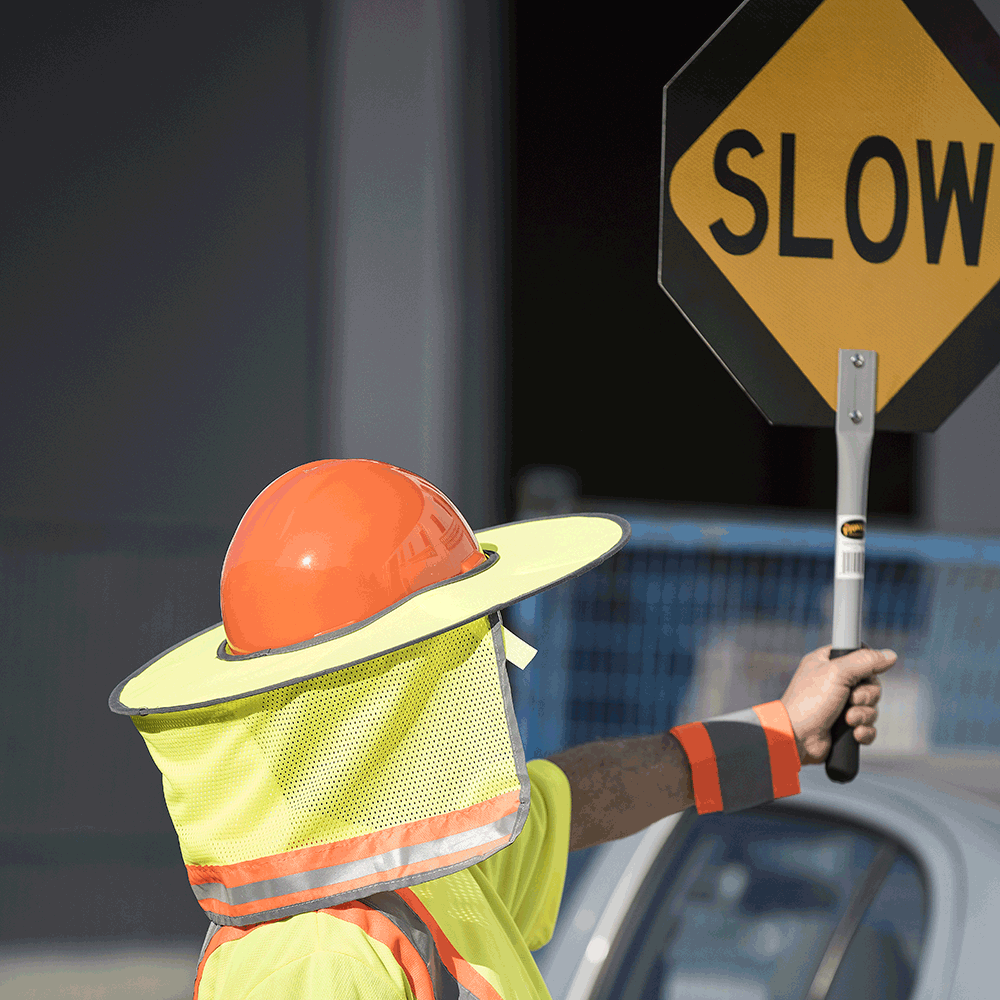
[702,708,774,812]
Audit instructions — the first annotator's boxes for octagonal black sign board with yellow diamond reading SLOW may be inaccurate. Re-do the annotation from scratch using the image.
[660,0,1000,431]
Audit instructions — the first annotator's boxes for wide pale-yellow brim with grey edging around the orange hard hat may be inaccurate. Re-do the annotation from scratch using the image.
[108,514,630,715]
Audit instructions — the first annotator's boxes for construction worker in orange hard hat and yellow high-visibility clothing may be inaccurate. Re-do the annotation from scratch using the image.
[109,460,895,1000]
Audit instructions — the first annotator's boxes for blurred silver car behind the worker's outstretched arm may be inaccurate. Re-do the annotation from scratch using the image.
[536,754,1000,1000]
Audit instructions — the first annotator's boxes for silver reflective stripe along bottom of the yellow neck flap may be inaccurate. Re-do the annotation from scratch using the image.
[191,813,519,908]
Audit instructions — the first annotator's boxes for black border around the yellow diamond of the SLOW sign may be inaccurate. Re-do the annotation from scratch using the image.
[659,0,1000,431]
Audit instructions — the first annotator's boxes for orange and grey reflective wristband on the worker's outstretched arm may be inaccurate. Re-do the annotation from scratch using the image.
[670,701,800,813]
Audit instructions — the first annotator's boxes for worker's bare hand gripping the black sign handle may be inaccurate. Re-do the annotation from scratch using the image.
[781,646,896,764]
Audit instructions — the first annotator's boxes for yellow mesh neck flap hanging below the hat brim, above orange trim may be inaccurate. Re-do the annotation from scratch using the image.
[132,614,530,881]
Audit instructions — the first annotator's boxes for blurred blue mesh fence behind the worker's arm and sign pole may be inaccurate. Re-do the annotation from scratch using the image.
[508,518,1000,758]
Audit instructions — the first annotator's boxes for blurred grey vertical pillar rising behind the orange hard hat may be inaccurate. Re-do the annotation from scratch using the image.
[323,0,505,527]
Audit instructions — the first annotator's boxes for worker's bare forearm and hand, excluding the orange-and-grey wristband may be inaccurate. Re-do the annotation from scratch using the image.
[549,646,896,851]
